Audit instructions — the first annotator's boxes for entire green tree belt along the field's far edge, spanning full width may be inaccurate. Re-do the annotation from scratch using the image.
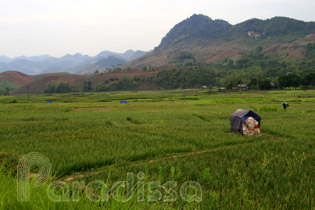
[0,43,315,94]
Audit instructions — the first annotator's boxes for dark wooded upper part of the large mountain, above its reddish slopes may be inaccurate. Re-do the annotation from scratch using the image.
[158,15,315,49]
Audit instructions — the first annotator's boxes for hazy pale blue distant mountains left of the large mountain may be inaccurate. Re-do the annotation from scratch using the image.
[0,50,147,75]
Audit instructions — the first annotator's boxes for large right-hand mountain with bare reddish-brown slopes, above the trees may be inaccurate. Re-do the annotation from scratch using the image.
[126,14,315,71]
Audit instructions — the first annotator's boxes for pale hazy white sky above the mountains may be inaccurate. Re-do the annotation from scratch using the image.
[0,0,315,57]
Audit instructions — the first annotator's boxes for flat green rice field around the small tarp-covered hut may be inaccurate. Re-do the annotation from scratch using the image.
[0,90,315,209]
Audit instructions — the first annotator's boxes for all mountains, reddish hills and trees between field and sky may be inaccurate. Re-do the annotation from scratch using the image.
[0,15,315,94]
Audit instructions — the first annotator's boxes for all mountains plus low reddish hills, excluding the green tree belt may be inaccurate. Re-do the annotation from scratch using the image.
[0,15,315,94]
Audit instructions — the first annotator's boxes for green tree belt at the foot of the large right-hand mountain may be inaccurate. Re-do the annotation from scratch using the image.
[84,50,315,91]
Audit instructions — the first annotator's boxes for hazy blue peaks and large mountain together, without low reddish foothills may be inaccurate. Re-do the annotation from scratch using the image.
[0,14,315,75]
